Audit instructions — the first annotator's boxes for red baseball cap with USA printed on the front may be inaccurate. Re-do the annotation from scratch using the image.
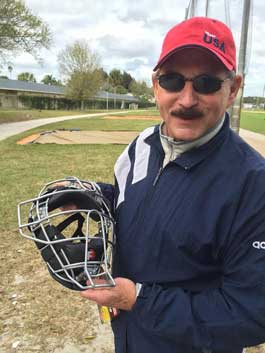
[154,17,236,71]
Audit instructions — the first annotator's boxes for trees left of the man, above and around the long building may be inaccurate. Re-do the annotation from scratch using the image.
[0,0,153,101]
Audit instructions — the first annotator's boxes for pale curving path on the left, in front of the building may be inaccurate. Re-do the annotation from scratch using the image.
[0,111,128,141]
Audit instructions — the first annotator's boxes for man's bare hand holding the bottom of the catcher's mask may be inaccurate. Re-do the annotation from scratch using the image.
[81,277,136,310]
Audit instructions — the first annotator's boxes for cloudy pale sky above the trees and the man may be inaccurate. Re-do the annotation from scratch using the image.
[0,0,265,96]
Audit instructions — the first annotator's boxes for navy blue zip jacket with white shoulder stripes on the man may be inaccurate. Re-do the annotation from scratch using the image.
[100,116,265,353]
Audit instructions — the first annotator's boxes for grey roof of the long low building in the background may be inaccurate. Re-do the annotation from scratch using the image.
[0,78,138,102]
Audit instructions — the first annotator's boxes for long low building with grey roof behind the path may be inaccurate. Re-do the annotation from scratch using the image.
[0,78,138,109]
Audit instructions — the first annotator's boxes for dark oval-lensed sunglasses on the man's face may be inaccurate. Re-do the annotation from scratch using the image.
[157,72,230,94]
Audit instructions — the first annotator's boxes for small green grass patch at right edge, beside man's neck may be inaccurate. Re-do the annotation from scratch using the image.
[240,110,265,135]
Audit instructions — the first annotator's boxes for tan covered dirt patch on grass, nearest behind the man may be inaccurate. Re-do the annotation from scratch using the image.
[17,130,139,145]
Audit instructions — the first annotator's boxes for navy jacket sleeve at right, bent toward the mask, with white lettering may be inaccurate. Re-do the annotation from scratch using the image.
[133,169,265,352]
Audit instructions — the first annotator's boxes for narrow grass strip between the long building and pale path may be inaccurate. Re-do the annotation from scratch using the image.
[0,109,109,124]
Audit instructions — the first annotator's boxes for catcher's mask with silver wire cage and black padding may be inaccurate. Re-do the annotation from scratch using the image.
[18,177,115,290]
